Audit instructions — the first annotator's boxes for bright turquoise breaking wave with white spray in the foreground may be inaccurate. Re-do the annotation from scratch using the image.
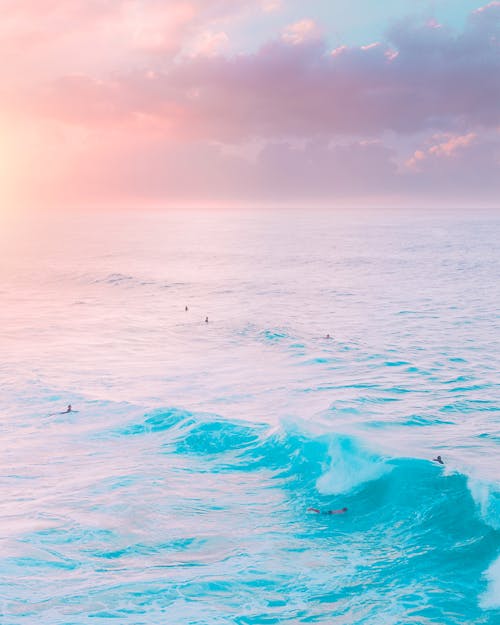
[97,408,500,610]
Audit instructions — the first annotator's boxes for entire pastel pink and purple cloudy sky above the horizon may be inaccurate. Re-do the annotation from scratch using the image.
[0,0,500,211]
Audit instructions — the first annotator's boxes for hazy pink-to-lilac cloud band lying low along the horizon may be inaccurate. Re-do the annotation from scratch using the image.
[6,119,500,207]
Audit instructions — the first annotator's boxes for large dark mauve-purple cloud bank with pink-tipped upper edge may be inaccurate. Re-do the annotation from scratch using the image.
[23,4,500,141]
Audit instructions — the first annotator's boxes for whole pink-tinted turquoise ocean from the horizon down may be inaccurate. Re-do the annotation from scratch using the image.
[0,210,500,625]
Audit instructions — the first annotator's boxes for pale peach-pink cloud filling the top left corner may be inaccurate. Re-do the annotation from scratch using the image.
[0,0,284,83]
